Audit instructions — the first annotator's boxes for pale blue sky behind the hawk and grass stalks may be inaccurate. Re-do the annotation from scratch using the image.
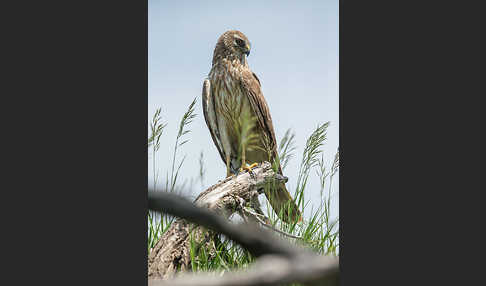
[148,0,339,221]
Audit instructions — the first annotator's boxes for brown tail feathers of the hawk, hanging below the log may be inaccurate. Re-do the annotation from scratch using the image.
[265,183,302,223]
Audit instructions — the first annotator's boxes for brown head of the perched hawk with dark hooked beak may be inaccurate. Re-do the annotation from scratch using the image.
[213,30,251,66]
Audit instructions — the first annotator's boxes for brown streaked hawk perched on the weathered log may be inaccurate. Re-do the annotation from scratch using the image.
[202,30,301,223]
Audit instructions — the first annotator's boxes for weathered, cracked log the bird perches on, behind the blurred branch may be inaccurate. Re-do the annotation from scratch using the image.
[148,162,285,279]
